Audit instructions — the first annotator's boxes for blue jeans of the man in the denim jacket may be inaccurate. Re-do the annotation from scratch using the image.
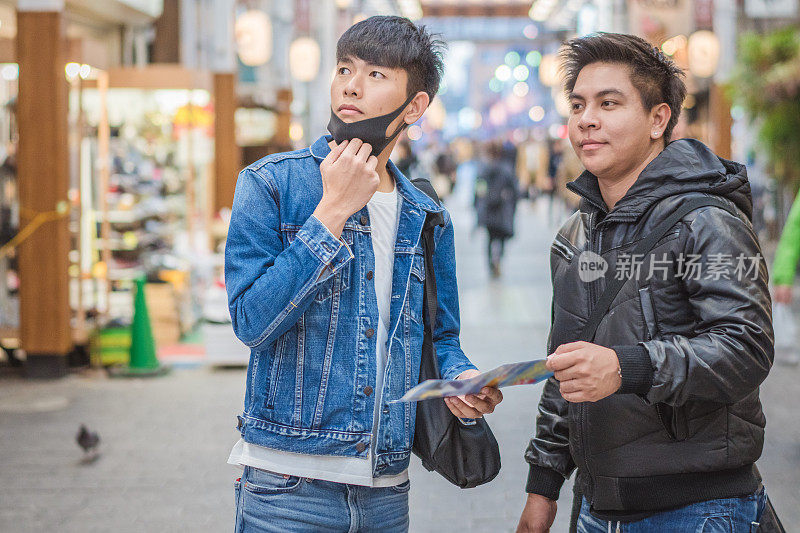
[230,466,410,533]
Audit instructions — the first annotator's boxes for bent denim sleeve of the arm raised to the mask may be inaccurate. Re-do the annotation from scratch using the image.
[225,166,353,350]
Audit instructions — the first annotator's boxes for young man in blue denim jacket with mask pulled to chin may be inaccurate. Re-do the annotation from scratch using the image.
[225,17,502,532]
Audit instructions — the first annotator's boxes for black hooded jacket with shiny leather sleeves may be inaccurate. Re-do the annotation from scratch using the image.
[525,139,773,512]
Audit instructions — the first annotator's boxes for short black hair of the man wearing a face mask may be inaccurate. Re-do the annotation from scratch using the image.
[336,16,447,101]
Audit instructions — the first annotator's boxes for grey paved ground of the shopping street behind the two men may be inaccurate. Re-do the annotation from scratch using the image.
[0,197,800,533]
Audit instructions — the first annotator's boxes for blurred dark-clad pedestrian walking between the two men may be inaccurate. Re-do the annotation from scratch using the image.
[476,142,520,278]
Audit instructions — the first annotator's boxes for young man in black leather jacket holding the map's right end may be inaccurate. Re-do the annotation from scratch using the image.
[518,34,773,533]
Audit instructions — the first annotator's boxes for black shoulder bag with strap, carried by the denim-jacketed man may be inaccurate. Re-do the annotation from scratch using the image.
[412,179,500,489]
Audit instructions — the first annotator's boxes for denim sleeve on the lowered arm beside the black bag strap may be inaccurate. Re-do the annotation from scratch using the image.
[433,213,475,379]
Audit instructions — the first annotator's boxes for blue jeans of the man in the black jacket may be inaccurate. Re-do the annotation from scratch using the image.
[578,487,767,533]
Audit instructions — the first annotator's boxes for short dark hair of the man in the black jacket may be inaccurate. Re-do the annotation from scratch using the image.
[559,33,686,143]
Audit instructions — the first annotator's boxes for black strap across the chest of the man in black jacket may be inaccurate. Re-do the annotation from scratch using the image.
[580,196,739,342]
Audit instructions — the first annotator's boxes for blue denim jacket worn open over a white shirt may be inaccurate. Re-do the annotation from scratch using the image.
[225,137,475,476]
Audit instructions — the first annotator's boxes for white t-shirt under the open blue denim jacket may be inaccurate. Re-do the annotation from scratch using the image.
[228,183,408,487]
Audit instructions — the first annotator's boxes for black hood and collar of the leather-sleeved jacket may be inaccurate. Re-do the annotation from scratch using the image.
[567,139,753,221]
